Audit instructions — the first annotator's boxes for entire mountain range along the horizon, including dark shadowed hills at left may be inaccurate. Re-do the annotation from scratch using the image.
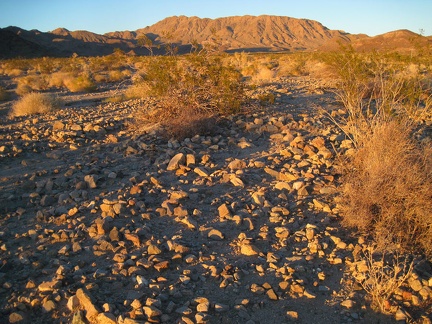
[0,15,432,58]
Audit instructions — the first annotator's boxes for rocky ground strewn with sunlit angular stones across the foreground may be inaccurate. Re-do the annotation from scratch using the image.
[0,78,432,324]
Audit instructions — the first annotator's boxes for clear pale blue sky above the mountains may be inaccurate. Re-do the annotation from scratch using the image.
[0,0,432,36]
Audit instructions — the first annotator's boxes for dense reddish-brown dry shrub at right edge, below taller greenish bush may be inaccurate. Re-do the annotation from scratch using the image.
[342,119,432,257]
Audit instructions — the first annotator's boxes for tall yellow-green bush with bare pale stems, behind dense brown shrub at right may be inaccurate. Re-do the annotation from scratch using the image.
[327,49,432,144]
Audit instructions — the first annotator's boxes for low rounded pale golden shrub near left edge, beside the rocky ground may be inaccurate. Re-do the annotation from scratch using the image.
[10,92,62,117]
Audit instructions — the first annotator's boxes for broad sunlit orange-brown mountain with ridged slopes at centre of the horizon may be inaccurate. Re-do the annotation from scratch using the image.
[137,15,350,51]
